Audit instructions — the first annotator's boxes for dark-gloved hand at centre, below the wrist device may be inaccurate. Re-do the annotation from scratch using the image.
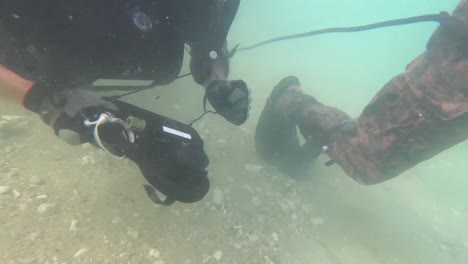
[206,80,251,126]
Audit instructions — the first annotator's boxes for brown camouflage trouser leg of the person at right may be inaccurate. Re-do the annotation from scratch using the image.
[299,0,468,184]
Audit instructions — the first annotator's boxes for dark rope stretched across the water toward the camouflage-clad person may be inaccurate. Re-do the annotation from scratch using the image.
[238,12,448,51]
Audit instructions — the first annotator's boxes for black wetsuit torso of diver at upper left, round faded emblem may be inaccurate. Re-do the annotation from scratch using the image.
[0,0,239,85]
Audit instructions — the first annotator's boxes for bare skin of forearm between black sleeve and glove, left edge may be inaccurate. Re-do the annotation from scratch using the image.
[0,64,34,104]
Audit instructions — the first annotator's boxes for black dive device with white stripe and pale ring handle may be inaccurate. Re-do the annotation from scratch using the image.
[84,97,210,205]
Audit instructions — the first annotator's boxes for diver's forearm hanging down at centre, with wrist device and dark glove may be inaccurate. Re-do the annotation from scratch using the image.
[186,0,250,125]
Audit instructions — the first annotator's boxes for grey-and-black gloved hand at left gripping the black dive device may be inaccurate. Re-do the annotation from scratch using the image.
[25,84,119,145]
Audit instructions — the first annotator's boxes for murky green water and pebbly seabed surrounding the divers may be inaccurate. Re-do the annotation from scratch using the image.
[0,0,468,264]
